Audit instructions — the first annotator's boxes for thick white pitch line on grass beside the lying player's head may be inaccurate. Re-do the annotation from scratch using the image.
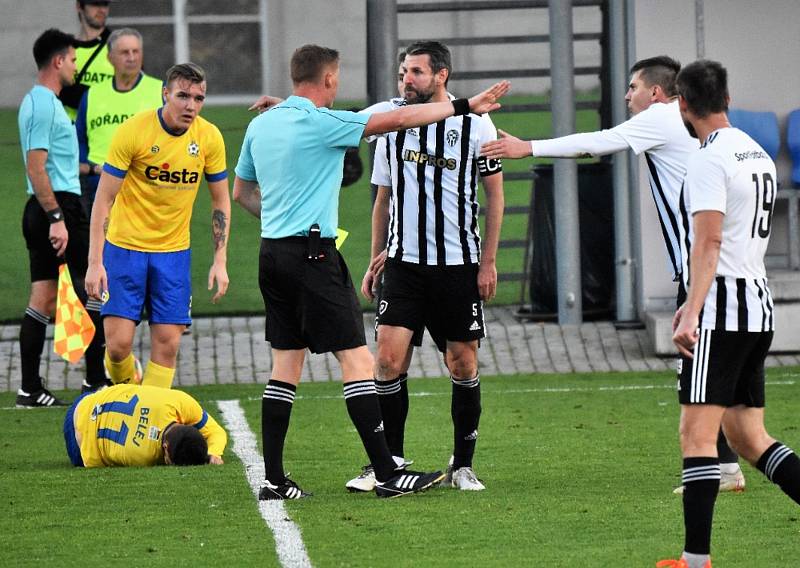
[217,400,311,568]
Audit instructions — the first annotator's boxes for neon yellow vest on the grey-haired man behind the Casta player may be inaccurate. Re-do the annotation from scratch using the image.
[86,73,163,164]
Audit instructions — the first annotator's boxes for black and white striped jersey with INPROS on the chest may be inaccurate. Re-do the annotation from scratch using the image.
[369,99,502,266]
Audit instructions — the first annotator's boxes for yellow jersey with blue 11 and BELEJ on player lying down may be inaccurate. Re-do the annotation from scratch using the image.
[74,384,228,467]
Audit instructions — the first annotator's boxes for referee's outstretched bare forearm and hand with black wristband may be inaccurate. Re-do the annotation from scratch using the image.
[363,81,511,138]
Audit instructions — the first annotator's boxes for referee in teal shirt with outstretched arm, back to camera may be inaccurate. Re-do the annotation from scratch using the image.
[233,45,509,499]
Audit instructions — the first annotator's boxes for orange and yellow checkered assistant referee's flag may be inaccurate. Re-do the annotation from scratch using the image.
[53,264,95,363]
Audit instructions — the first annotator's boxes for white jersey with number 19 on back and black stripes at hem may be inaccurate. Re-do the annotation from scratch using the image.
[681,128,777,331]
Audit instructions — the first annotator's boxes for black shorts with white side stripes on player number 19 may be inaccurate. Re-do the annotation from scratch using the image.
[678,329,772,408]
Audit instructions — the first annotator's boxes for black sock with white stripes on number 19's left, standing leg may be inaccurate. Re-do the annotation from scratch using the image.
[683,457,720,554]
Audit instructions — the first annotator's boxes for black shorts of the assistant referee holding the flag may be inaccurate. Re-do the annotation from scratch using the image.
[22,191,89,284]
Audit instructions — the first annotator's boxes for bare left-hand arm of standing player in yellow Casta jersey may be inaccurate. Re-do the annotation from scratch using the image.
[84,171,123,300]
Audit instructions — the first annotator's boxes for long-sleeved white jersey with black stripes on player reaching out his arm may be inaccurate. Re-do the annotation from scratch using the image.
[532,101,699,281]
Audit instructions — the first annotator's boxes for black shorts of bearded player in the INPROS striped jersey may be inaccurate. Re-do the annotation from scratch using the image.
[378,258,486,353]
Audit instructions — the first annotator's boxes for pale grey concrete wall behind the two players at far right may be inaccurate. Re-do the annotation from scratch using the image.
[634,0,800,307]
